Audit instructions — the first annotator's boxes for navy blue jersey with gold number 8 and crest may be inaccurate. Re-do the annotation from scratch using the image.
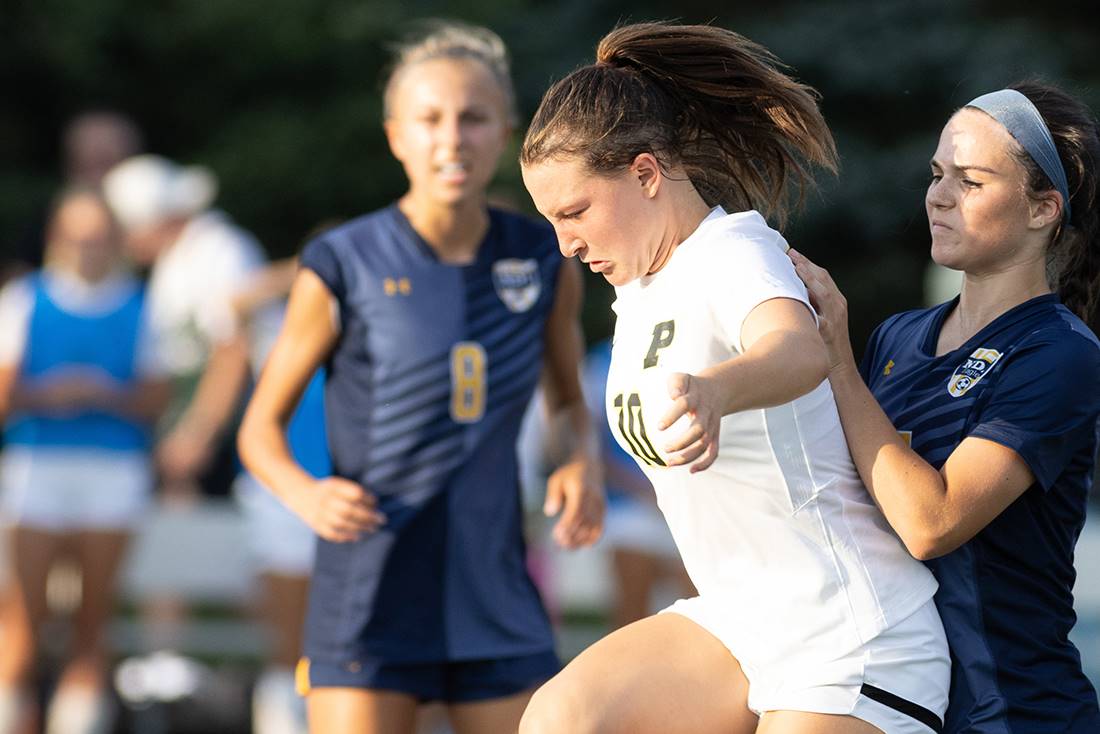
[301,205,562,666]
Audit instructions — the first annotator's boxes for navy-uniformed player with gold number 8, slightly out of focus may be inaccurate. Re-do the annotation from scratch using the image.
[239,24,603,734]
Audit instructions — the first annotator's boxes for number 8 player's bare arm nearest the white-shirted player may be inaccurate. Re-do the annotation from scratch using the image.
[542,260,604,548]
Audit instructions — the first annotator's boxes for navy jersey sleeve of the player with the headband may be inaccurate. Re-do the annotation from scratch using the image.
[969,331,1100,490]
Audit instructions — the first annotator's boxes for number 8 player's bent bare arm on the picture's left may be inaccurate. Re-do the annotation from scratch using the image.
[238,270,384,541]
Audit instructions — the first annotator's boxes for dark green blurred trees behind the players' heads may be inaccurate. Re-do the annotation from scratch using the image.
[0,0,1100,352]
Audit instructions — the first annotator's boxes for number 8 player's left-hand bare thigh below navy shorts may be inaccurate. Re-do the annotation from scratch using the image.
[306,688,417,734]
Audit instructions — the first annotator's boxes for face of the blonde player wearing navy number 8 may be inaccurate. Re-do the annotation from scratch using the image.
[386,58,512,206]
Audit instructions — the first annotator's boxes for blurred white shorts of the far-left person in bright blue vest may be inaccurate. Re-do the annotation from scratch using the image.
[0,446,153,533]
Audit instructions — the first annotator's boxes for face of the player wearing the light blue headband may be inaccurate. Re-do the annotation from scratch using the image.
[924,108,1042,274]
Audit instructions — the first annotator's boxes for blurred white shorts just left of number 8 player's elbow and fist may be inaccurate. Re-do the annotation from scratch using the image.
[233,472,316,576]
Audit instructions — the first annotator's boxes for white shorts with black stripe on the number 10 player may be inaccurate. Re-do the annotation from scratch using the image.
[664,596,950,734]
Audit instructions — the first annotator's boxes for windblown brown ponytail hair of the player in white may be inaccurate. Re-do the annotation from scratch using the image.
[520,23,837,222]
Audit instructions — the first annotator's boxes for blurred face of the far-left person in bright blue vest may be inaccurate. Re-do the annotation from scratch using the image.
[50,196,119,277]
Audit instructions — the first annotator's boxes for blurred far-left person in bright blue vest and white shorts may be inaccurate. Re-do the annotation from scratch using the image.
[0,187,168,734]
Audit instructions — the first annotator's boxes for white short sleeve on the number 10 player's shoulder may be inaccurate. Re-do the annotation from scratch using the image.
[704,230,816,352]
